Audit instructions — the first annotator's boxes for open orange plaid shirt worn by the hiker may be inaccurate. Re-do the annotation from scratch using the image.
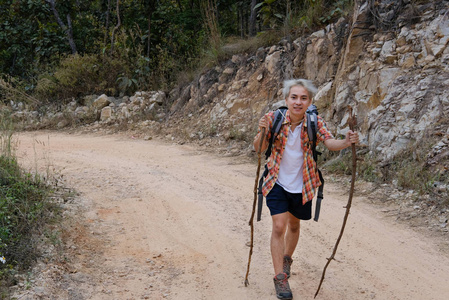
[259,110,334,204]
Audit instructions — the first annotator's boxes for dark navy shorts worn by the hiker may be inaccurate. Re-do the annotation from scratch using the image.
[266,183,312,220]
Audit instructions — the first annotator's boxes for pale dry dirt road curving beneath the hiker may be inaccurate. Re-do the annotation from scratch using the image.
[14,132,449,300]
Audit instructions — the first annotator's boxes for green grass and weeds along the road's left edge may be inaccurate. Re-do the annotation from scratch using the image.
[0,113,57,290]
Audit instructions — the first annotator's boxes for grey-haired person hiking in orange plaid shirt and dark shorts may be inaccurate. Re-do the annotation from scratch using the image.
[254,79,359,299]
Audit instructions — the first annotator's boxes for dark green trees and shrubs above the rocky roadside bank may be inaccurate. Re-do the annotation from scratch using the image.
[0,0,353,103]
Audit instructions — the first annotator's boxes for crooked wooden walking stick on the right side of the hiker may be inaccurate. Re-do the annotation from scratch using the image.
[314,106,357,298]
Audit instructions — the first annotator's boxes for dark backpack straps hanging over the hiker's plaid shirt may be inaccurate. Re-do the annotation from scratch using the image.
[257,104,324,222]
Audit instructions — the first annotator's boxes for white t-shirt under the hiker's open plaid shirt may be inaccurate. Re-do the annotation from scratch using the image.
[276,123,304,193]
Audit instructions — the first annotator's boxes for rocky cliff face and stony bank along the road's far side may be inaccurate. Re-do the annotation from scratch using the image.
[6,0,449,180]
